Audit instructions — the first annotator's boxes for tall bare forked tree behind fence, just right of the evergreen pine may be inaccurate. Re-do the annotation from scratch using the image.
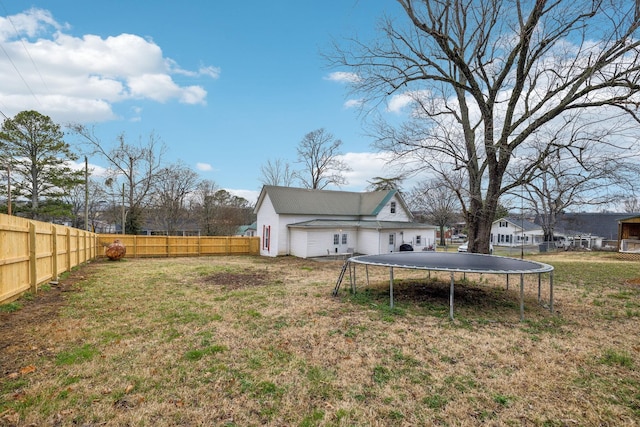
[71,125,166,234]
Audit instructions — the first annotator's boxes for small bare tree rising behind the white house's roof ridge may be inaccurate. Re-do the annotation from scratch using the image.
[295,129,351,190]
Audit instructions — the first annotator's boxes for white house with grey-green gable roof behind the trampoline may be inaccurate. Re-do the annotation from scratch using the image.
[254,185,436,258]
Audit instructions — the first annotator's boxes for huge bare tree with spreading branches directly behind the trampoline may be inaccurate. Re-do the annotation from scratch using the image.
[331,0,640,253]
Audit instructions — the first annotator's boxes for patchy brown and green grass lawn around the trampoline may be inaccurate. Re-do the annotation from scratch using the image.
[0,252,640,426]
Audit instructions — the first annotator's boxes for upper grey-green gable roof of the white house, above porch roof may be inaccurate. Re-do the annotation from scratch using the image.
[254,185,411,216]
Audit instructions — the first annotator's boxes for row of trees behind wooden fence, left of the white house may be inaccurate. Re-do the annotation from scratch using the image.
[0,111,255,236]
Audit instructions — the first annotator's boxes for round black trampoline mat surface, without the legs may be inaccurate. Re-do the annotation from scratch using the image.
[349,251,553,274]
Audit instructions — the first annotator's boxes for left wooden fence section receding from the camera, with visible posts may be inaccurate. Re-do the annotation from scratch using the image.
[0,214,98,304]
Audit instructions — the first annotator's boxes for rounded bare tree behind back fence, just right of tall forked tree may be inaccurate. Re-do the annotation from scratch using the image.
[153,163,198,236]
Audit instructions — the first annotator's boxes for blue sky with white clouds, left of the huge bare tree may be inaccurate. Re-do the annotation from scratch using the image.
[0,0,408,201]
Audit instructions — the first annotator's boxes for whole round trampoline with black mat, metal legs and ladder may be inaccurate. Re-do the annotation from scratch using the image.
[333,251,553,320]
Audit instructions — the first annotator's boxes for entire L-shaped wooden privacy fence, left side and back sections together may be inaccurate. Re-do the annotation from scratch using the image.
[0,214,260,304]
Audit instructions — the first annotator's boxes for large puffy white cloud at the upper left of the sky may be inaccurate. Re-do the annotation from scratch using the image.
[0,8,220,122]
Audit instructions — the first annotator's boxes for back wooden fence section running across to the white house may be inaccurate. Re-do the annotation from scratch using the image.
[98,234,260,258]
